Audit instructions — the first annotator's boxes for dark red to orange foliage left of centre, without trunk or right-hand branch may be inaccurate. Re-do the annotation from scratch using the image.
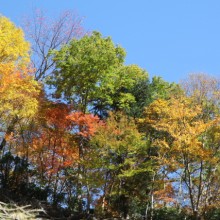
[31,104,78,176]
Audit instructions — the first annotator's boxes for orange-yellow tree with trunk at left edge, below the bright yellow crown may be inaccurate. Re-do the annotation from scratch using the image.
[0,63,40,188]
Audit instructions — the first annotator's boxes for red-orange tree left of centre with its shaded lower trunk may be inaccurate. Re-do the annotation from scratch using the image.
[29,103,79,205]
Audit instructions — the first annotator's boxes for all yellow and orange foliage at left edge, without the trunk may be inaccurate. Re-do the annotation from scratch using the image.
[0,16,40,149]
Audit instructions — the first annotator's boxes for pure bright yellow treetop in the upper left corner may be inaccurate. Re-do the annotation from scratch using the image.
[0,16,30,64]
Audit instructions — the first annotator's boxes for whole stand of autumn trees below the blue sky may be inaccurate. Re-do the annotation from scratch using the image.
[0,11,220,220]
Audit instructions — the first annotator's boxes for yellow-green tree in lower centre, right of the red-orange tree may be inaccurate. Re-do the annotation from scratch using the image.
[92,112,152,218]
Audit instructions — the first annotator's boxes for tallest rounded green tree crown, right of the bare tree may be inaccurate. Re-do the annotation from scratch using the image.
[49,32,125,113]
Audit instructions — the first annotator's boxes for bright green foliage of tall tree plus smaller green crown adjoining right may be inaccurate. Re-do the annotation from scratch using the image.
[48,32,151,117]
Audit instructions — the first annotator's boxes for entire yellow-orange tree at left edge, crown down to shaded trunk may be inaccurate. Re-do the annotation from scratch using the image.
[0,16,41,192]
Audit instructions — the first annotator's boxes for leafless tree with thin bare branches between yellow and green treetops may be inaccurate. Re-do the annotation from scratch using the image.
[23,10,85,81]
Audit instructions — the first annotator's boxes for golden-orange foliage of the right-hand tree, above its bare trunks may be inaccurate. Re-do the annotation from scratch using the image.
[142,96,215,166]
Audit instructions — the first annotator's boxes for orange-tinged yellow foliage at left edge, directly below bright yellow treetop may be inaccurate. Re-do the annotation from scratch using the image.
[0,63,40,118]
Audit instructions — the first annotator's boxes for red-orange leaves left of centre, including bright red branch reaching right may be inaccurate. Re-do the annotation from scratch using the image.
[31,103,99,177]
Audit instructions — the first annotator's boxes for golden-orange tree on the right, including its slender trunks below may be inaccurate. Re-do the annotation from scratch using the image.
[141,96,219,219]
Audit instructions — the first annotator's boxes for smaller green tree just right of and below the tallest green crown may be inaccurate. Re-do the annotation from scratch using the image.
[93,65,148,117]
